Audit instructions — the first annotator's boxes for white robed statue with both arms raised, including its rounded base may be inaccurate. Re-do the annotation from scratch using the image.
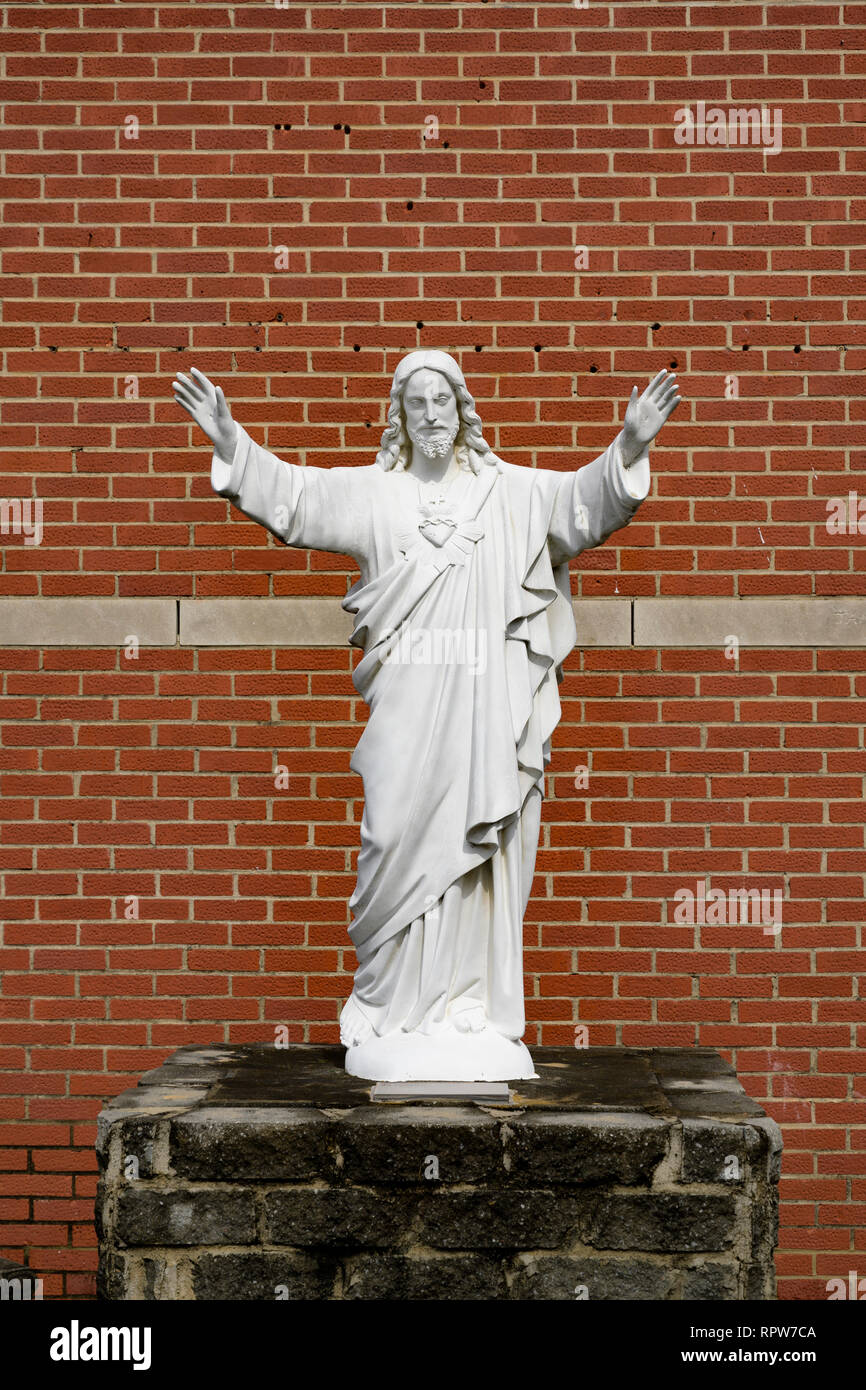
[174,352,680,1081]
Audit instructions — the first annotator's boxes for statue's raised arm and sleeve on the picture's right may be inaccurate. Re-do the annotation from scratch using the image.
[549,371,681,564]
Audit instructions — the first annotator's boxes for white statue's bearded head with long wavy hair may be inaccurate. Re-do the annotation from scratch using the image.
[375,349,498,473]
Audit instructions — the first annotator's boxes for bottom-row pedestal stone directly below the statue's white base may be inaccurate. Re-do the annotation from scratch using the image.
[342,1254,507,1301]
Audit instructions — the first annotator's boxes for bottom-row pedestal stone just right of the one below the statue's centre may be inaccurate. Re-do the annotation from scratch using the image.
[512,1254,677,1301]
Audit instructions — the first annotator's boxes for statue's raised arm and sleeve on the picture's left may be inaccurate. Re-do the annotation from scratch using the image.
[174,367,370,562]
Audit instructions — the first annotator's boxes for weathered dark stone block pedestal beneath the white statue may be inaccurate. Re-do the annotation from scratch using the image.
[97,1044,781,1300]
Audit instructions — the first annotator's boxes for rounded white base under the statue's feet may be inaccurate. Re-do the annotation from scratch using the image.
[346,1027,538,1081]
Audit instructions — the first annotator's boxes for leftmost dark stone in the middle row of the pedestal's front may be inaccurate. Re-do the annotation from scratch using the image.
[117,1187,256,1245]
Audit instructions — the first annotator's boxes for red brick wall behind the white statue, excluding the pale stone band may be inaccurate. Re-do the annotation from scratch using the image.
[0,0,866,1298]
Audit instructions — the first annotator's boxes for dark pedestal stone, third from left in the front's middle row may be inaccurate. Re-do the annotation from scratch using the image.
[418,1188,578,1250]
